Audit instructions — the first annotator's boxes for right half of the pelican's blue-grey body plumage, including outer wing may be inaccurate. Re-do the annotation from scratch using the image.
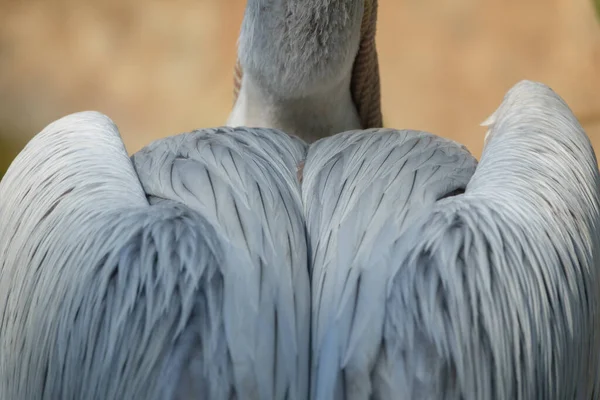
[302,81,600,400]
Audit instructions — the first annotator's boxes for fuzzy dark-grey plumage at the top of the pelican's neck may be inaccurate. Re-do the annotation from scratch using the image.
[239,0,364,99]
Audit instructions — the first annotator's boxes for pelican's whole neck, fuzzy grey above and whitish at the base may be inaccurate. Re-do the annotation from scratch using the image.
[228,0,364,140]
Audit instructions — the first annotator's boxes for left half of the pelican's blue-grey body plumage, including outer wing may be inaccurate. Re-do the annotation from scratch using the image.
[0,113,309,399]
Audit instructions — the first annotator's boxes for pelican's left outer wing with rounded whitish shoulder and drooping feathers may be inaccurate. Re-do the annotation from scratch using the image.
[0,113,308,399]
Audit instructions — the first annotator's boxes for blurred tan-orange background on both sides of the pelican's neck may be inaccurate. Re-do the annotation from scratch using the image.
[0,0,600,176]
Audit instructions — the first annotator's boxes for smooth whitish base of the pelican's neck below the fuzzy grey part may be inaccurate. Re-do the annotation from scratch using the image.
[227,73,361,142]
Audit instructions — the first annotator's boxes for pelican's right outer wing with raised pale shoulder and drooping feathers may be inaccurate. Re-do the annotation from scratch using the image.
[379,82,600,399]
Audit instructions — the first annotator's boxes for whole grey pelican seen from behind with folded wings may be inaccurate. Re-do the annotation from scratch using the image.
[0,0,600,400]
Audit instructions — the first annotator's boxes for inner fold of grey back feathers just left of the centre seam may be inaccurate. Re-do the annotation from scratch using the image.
[133,128,310,399]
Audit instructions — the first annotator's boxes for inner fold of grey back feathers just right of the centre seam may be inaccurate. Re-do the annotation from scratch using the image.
[303,130,476,399]
